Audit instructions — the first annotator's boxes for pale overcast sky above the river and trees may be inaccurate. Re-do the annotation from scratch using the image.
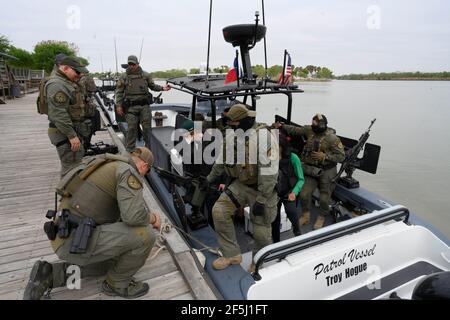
[0,0,450,75]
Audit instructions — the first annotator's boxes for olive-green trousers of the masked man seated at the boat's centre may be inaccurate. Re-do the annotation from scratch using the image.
[212,180,278,258]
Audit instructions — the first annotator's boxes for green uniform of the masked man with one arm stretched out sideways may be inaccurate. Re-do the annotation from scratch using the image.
[283,121,345,224]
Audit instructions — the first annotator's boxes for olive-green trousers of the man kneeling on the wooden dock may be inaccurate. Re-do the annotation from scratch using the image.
[52,222,155,288]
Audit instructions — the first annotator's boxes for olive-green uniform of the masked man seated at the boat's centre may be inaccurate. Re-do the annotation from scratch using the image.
[207,107,278,269]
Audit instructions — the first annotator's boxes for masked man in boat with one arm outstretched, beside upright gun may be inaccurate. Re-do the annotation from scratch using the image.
[274,114,345,230]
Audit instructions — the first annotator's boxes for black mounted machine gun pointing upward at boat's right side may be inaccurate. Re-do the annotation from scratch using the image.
[332,119,377,189]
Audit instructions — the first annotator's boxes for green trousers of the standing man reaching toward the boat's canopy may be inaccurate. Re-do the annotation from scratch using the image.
[125,105,152,152]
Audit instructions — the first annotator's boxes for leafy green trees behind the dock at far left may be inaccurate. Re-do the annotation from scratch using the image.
[0,35,89,73]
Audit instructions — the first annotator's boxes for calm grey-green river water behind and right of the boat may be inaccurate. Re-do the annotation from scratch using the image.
[159,81,450,238]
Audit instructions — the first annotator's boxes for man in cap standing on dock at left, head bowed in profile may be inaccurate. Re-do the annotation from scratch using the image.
[44,56,91,176]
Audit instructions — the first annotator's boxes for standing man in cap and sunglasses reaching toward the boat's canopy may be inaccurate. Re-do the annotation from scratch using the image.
[116,56,171,151]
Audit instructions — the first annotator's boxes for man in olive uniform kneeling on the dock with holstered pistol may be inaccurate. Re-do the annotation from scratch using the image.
[24,148,161,300]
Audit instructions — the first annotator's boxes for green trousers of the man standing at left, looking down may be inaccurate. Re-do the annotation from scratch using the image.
[48,128,85,177]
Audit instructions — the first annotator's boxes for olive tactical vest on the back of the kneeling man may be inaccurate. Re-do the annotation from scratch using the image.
[56,154,131,225]
